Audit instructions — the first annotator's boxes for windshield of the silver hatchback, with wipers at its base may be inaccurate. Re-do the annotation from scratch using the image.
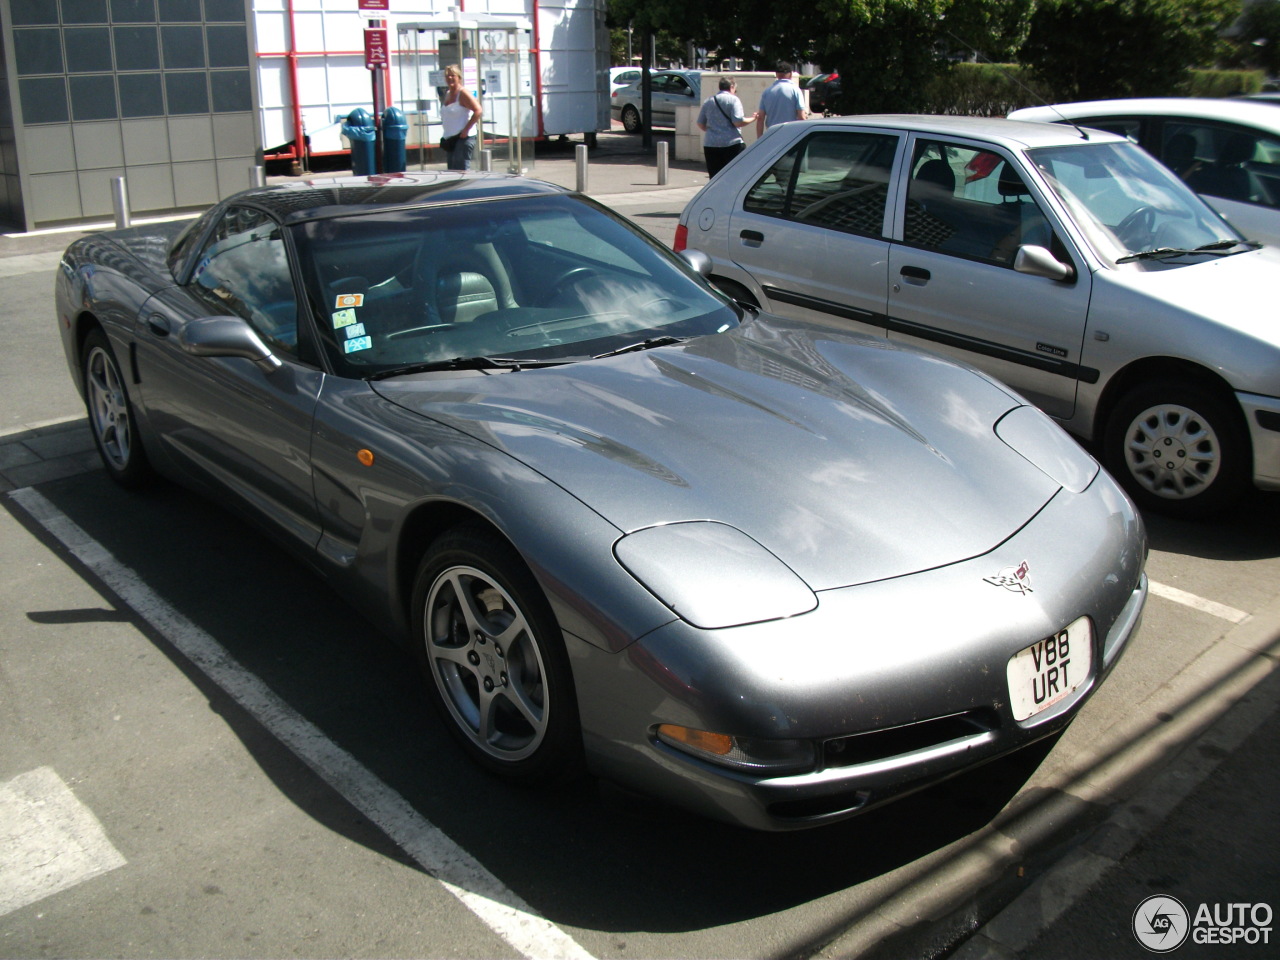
[1029,142,1240,262]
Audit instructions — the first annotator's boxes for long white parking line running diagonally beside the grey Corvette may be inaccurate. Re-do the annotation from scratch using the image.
[9,486,591,960]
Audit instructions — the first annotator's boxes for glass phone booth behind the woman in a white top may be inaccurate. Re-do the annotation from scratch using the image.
[396,13,538,174]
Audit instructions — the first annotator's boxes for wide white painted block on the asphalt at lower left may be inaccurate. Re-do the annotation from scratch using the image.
[0,767,125,916]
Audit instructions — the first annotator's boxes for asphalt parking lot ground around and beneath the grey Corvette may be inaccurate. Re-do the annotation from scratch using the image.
[0,140,1280,957]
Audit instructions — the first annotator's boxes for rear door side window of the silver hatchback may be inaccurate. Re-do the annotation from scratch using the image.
[744,132,897,237]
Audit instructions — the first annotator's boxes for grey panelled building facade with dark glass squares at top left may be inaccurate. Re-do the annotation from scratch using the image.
[0,0,261,230]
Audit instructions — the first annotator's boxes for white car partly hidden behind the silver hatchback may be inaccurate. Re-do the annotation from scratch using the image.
[1009,97,1280,244]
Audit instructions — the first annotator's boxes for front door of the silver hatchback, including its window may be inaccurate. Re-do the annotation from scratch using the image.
[887,134,1096,420]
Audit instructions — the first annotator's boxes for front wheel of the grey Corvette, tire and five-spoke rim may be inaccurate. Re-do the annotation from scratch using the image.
[412,525,582,783]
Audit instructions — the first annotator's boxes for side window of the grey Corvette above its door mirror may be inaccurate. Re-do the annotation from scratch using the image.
[189,207,298,353]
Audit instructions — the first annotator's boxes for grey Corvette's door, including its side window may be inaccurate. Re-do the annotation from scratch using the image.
[137,206,324,545]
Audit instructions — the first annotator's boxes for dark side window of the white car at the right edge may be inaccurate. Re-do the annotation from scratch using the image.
[1161,122,1280,206]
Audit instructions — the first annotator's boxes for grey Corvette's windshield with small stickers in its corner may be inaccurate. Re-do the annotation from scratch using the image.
[285,196,739,378]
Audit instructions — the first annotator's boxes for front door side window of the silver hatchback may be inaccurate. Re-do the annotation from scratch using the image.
[902,141,1053,266]
